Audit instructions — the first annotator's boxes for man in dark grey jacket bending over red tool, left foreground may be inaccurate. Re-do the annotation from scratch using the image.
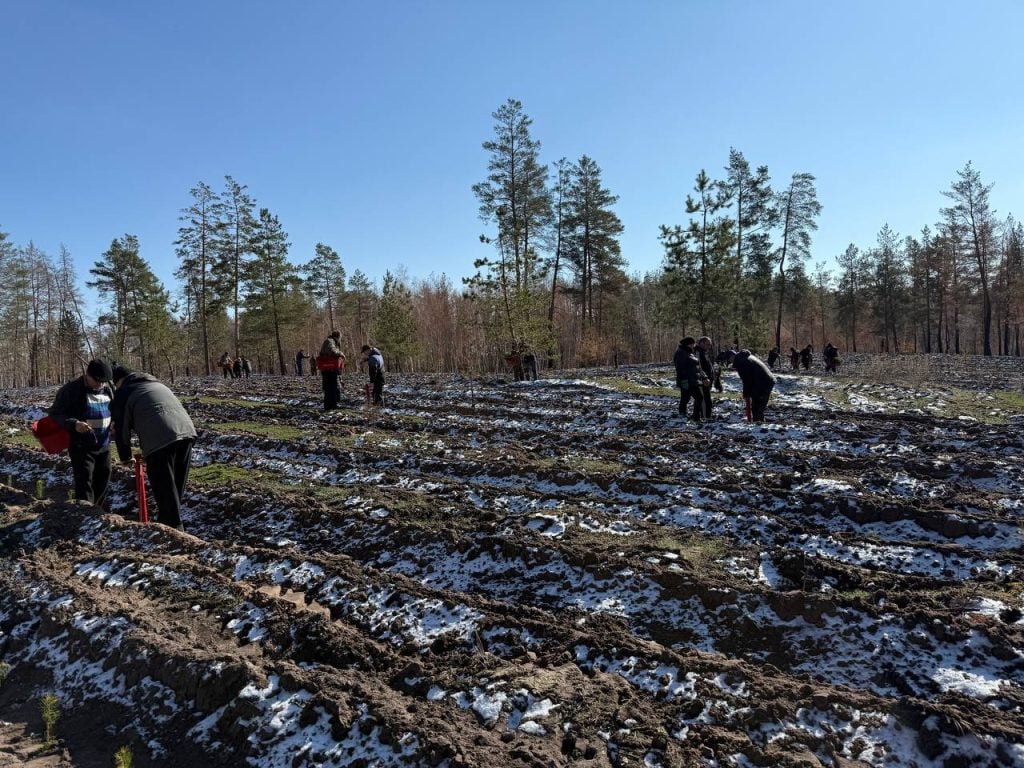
[111,366,196,530]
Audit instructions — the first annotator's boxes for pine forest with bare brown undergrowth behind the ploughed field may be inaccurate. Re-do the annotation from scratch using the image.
[0,98,1024,387]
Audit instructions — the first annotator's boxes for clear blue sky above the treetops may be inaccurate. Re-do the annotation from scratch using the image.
[0,0,1024,311]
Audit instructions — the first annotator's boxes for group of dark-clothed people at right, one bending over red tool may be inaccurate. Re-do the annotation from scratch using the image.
[673,336,775,424]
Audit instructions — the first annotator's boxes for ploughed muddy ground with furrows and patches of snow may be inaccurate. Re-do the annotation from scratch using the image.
[0,355,1024,768]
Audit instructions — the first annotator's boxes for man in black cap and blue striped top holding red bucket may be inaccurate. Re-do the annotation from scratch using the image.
[48,360,114,507]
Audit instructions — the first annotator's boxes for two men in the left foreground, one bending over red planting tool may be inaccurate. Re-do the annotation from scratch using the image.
[49,359,197,530]
